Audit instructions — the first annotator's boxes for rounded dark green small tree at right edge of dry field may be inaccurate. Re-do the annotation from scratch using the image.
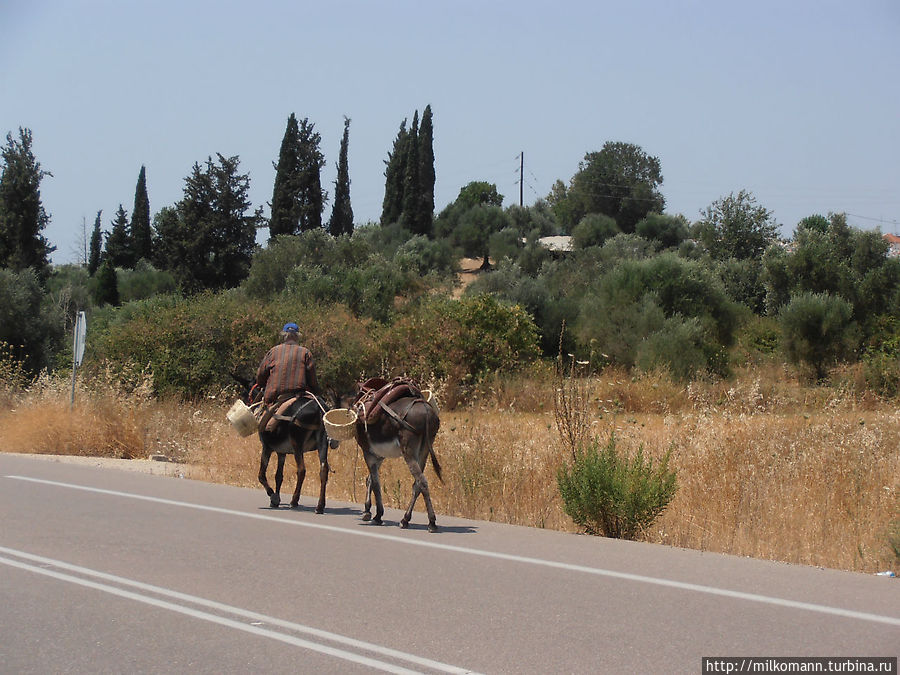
[779,293,855,380]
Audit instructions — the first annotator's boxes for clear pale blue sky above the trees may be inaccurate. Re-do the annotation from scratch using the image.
[0,0,900,262]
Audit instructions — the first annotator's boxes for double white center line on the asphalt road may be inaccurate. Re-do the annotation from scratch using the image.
[0,546,473,674]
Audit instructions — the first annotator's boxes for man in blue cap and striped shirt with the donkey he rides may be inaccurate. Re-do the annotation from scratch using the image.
[251,322,329,513]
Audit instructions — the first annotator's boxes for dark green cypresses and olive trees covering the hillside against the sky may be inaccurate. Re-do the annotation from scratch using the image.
[0,114,900,392]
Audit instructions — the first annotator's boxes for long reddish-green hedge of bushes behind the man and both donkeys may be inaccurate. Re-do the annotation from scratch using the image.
[85,284,539,398]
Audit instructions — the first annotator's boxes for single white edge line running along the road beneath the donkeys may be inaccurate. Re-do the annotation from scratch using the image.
[6,476,900,626]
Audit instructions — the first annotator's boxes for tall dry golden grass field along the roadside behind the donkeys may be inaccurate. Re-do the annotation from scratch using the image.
[0,366,900,572]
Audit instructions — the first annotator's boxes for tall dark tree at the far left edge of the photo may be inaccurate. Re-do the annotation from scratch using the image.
[0,127,56,283]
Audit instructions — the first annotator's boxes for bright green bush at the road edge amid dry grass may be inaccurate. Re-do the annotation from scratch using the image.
[556,436,677,539]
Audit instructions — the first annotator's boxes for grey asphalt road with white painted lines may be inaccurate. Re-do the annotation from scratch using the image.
[0,453,900,675]
